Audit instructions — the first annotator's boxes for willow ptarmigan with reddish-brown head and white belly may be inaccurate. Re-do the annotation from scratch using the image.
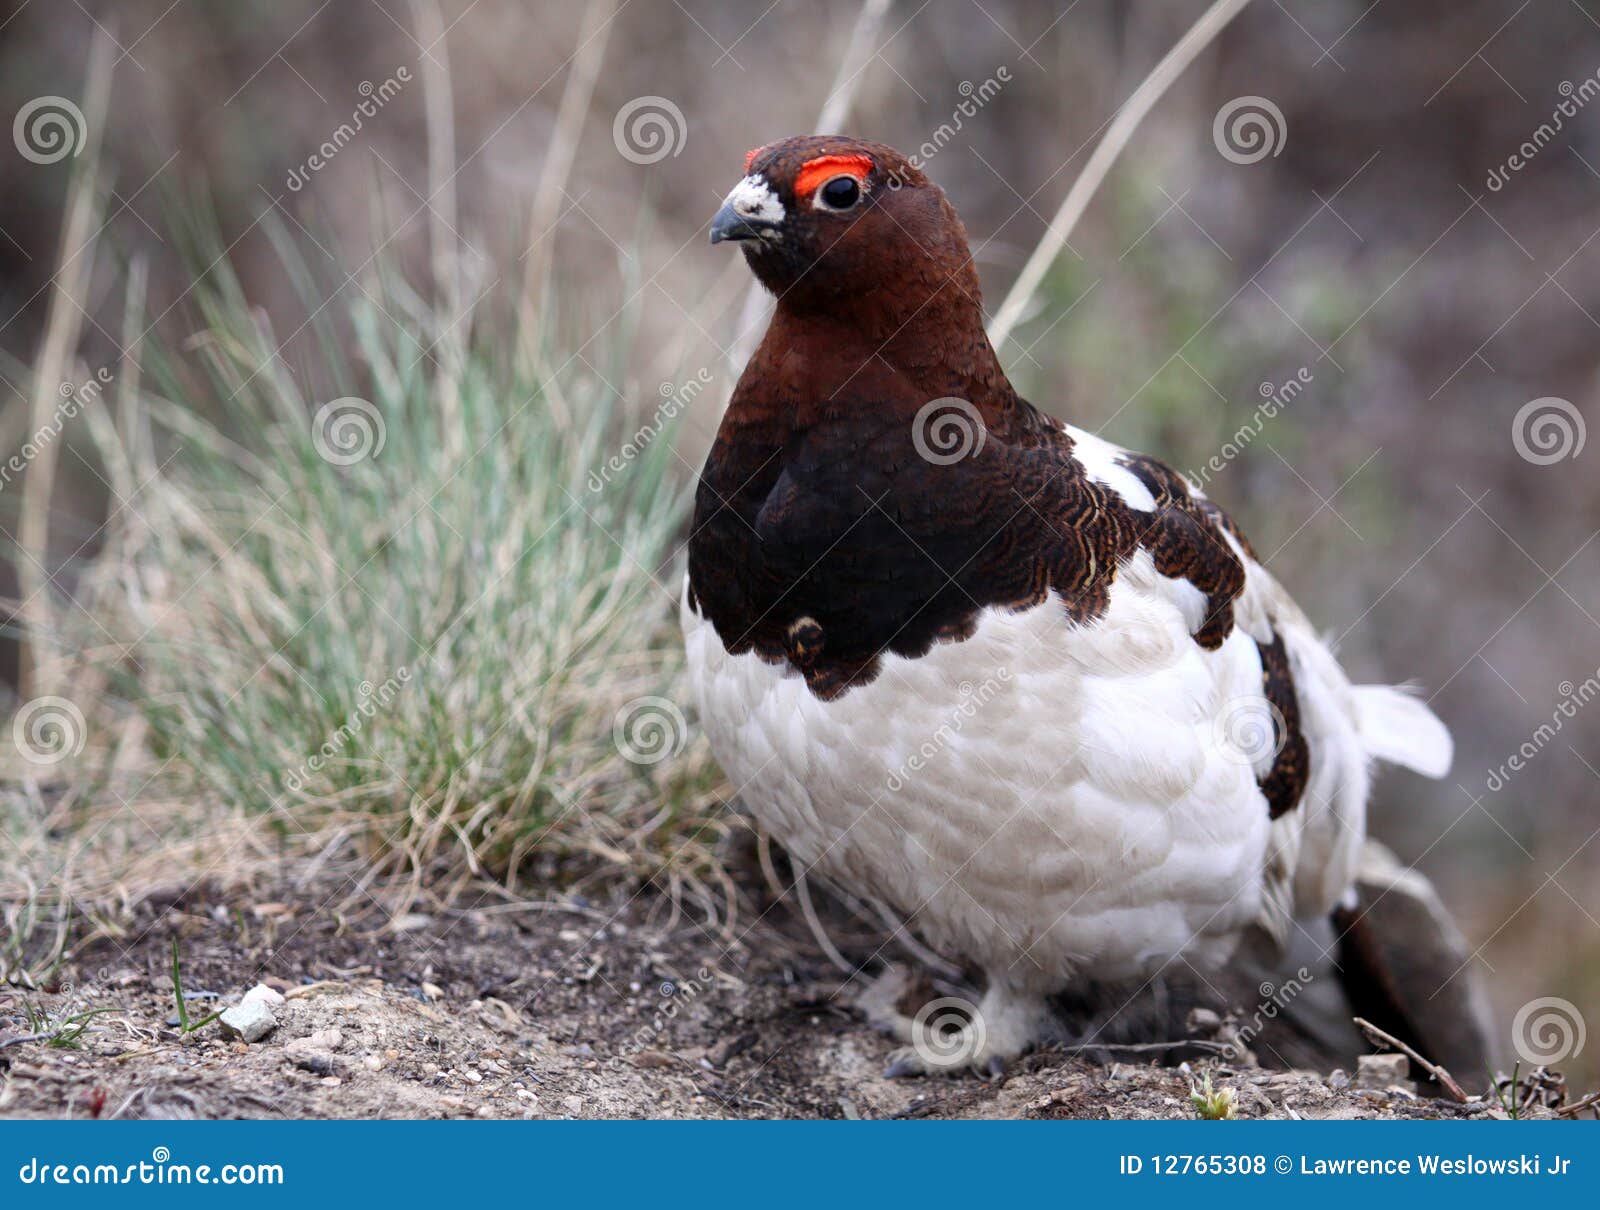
[682,136,1451,1071]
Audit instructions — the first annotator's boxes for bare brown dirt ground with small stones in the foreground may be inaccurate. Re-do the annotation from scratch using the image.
[0,887,1544,1119]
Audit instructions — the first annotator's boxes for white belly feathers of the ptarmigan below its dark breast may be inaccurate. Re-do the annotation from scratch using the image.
[683,551,1286,991]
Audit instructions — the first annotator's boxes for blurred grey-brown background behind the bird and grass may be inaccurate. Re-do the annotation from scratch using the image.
[0,0,1600,1074]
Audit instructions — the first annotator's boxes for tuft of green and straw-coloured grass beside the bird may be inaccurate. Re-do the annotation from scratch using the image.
[0,196,723,985]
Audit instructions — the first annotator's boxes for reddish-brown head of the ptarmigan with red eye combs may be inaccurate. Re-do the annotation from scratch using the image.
[710,134,978,312]
